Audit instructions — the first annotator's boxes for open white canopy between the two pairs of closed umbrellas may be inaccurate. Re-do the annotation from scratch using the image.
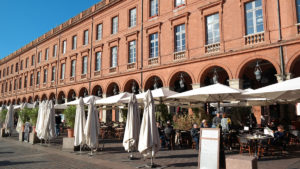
[95,92,132,105]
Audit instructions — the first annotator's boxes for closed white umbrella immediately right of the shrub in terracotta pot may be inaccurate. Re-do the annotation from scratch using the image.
[74,97,86,146]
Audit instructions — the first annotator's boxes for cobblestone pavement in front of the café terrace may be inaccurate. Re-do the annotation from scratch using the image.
[0,132,300,169]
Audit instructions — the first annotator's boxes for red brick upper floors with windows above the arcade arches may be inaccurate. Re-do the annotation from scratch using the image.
[0,0,300,90]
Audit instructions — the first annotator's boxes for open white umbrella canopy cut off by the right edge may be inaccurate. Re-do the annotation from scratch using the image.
[244,77,300,101]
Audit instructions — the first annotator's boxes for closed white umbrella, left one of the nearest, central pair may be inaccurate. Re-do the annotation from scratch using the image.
[123,95,140,157]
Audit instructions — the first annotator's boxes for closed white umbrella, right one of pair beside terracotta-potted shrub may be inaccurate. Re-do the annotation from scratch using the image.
[84,95,99,152]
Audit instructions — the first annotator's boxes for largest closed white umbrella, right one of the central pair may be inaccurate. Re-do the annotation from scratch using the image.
[138,90,160,158]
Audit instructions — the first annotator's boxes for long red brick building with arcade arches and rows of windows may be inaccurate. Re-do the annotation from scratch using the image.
[0,0,300,123]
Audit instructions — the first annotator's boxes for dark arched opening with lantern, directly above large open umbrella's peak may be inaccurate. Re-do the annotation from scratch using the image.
[200,66,229,86]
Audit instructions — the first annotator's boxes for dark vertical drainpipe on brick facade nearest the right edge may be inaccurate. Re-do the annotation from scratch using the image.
[277,0,285,81]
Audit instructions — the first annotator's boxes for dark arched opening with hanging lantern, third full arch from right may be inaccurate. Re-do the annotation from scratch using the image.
[169,71,192,93]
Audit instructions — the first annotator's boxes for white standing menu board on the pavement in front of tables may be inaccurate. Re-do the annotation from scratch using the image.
[198,128,220,169]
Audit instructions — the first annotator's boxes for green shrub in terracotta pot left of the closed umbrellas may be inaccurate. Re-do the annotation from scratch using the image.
[63,106,76,137]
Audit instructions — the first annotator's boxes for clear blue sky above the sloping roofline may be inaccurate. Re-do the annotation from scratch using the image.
[0,0,101,59]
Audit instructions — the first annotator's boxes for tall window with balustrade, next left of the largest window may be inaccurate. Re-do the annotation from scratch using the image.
[206,13,220,44]
